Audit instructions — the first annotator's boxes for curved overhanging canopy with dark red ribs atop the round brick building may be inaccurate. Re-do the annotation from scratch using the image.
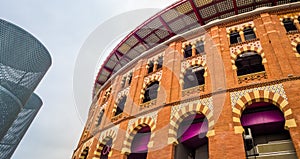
[93,0,297,96]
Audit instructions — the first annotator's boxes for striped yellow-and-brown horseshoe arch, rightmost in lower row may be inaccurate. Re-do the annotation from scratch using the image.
[232,90,297,134]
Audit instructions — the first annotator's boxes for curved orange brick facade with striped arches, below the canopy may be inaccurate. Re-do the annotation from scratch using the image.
[72,0,300,159]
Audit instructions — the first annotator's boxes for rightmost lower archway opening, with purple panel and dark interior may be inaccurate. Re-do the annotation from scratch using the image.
[241,102,297,159]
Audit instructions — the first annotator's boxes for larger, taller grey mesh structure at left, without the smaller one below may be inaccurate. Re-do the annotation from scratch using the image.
[0,19,51,149]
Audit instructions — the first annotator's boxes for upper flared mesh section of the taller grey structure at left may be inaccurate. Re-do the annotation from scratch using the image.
[0,20,51,104]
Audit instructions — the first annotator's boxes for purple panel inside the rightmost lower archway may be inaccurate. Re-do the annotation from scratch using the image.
[241,110,284,127]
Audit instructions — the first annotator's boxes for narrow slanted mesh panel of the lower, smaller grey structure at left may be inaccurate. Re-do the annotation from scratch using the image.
[0,94,42,159]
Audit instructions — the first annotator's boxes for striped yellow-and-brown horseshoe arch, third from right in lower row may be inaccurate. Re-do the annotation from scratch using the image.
[121,117,156,154]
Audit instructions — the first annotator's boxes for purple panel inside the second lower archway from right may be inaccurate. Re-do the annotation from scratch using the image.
[180,122,208,142]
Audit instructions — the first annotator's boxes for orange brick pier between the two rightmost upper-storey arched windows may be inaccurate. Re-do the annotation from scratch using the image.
[254,13,294,79]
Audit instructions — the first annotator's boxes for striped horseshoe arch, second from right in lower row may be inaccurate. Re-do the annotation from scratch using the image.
[168,103,215,144]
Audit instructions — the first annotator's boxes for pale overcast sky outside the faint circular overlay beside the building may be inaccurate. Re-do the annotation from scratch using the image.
[0,0,176,159]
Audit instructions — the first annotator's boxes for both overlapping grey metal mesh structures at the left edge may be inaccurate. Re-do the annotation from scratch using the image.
[0,19,51,158]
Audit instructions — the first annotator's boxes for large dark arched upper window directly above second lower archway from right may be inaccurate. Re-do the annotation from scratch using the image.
[183,66,205,89]
